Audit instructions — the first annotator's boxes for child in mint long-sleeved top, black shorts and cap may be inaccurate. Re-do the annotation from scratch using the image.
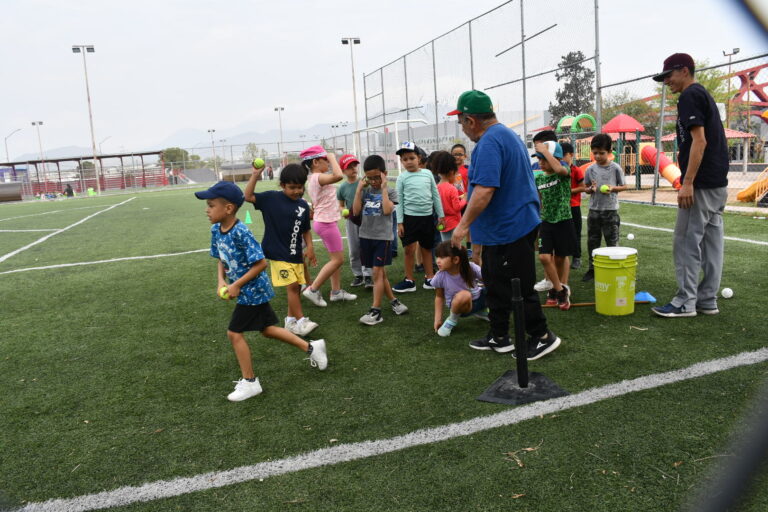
[392,141,445,293]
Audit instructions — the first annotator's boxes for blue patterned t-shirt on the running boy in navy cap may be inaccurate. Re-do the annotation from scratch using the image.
[211,220,275,306]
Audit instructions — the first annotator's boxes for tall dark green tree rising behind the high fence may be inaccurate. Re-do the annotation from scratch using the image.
[549,51,595,123]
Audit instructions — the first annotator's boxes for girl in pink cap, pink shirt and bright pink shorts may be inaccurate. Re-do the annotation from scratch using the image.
[300,146,357,307]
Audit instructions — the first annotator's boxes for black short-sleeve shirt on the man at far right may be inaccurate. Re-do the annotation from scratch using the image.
[677,83,728,188]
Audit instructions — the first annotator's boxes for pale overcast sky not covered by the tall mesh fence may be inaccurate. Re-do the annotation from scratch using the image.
[0,0,768,159]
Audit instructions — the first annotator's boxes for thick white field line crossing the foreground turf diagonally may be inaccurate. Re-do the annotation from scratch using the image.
[19,348,768,512]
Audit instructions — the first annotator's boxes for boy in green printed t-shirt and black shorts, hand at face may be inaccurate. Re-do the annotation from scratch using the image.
[535,141,576,311]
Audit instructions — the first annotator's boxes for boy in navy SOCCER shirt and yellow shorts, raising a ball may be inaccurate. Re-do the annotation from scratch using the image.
[245,164,317,336]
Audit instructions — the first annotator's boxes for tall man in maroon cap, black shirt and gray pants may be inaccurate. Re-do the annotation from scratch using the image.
[651,53,728,318]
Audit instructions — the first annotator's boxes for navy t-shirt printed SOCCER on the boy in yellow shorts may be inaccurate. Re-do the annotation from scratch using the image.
[253,190,309,263]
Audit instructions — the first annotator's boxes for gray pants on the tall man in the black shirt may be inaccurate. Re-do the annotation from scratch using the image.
[672,187,728,311]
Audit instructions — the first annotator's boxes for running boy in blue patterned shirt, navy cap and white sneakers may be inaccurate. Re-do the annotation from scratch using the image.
[195,181,328,402]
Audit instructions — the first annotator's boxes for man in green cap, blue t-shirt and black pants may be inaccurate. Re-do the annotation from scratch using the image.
[448,91,560,359]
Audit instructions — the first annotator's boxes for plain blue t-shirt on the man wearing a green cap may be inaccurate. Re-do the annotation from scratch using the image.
[469,123,541,245]
